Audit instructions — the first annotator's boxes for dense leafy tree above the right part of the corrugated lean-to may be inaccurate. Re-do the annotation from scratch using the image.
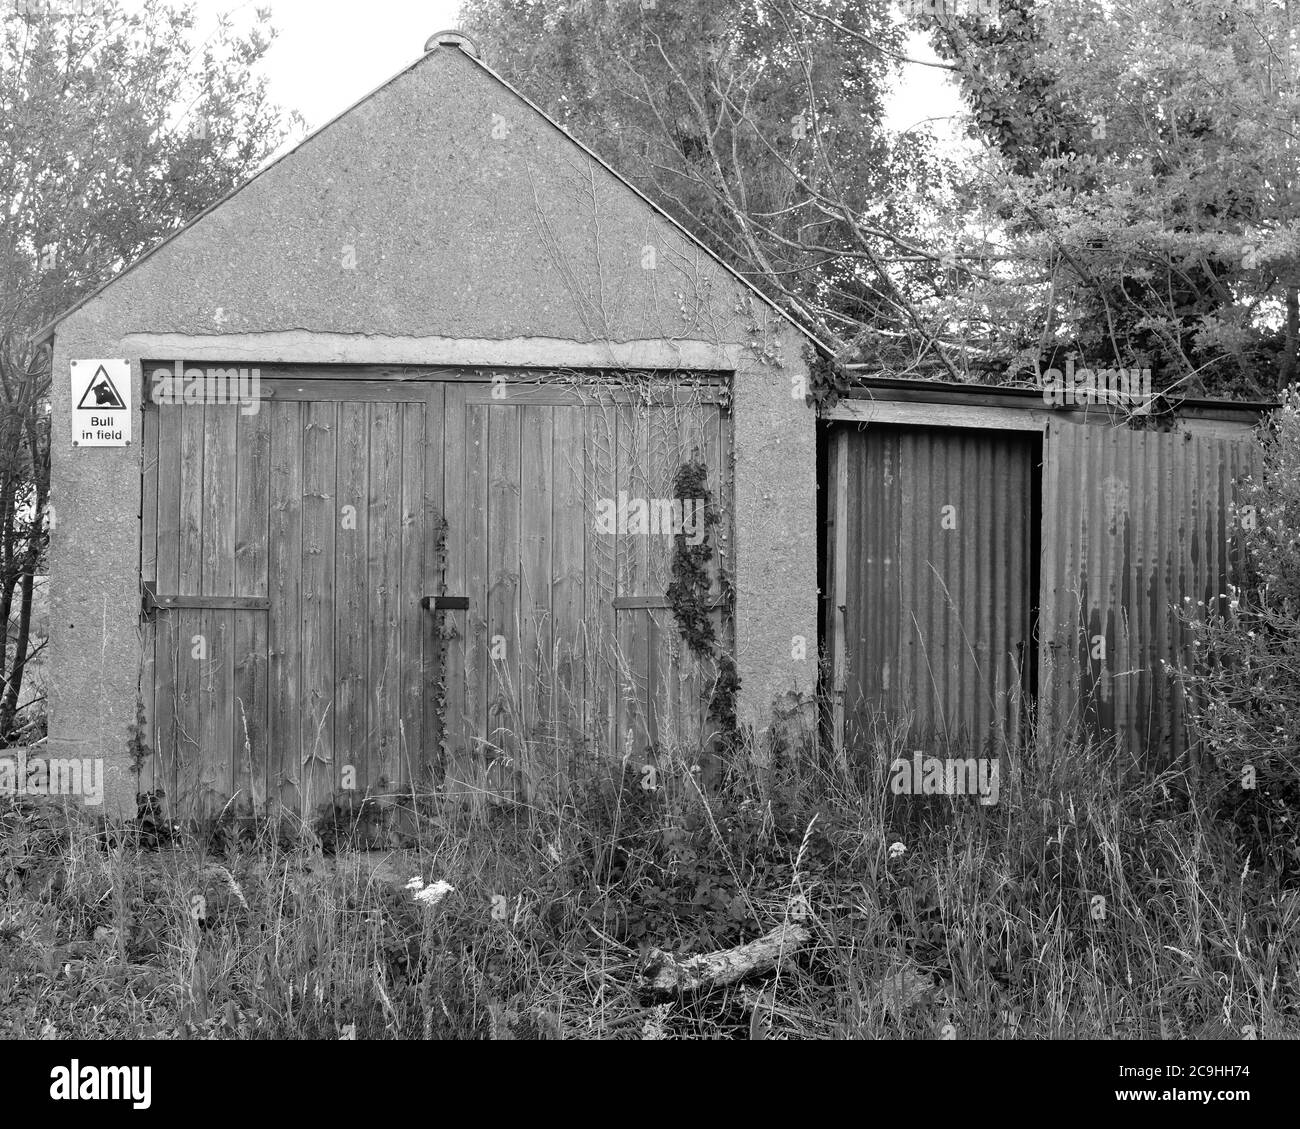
[926,0,1300,397]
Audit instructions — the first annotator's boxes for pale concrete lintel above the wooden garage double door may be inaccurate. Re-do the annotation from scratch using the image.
[111,329,740,372]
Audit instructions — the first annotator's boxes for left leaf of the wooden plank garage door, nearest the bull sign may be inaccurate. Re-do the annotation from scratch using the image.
[142,376,442,818]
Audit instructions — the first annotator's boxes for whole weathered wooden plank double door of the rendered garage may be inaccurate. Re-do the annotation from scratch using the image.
[142,363,731,816]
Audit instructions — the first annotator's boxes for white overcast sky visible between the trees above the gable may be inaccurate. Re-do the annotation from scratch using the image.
[183,0,958,156]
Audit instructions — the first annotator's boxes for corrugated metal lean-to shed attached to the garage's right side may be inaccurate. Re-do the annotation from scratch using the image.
[823,381,1269,770]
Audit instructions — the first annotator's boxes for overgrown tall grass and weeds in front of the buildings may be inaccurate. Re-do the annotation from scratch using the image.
[0,717,1300,1039]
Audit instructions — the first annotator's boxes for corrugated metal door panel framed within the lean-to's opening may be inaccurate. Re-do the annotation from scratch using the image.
[832,424,1039,758]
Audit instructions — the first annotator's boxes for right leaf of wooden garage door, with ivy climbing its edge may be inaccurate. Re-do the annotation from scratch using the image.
[443,381,731,805]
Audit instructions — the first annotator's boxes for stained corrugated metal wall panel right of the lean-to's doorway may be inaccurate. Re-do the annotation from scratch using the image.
[1039,420,1258,770]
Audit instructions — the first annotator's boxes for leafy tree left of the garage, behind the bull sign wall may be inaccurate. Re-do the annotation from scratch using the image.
[0,0,294,741]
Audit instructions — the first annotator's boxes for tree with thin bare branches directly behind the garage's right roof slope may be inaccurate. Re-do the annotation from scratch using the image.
[462,0,946,371]
